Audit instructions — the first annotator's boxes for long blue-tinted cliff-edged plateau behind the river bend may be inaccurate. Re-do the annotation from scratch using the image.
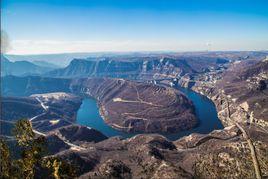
[46,55,227,79]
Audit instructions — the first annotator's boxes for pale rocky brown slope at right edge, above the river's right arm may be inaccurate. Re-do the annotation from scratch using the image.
[186,60,268,128]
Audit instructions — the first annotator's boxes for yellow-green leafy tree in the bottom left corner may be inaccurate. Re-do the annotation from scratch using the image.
[0,119,76,179]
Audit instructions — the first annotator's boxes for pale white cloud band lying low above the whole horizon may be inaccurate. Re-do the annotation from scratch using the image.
[9,39,268,54]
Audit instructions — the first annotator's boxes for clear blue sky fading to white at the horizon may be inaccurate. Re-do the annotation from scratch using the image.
[1,0,268,54]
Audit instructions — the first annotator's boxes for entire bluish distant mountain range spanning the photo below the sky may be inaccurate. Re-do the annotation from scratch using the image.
[1,52,267,79]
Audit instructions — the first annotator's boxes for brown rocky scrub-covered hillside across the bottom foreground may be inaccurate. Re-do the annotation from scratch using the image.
[47,126,268,179]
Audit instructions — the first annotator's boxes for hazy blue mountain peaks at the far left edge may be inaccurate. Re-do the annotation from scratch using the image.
[1,55,57,76]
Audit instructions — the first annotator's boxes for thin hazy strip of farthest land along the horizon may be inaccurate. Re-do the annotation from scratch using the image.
[5,51,267,67]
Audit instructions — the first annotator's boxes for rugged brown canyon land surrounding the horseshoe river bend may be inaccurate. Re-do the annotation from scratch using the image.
[1,52,268,178]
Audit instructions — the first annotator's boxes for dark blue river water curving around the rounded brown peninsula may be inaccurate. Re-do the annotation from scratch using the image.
[76,87,223,140]
